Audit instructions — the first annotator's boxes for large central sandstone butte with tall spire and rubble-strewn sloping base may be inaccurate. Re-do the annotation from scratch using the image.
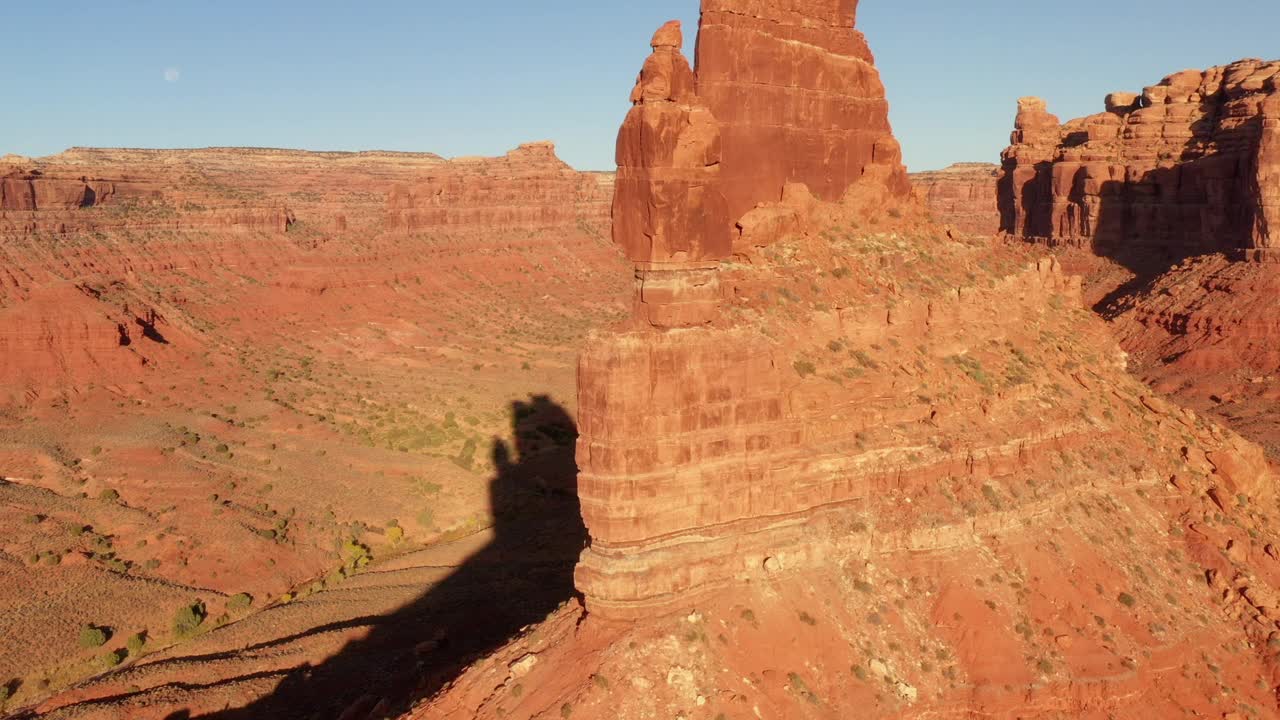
[410,9,1280,719]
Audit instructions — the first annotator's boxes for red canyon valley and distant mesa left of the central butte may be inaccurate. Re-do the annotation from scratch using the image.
[0,146,628,716]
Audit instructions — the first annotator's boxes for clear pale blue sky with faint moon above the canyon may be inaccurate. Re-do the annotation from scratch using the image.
[0,0,1280,170]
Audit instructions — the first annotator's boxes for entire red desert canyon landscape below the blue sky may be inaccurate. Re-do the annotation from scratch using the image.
[0,0,1280,720]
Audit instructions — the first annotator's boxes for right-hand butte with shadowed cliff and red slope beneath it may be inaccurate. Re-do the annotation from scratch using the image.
[1000,59,1280,476]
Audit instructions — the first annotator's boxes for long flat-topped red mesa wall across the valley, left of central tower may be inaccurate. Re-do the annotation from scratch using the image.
[0,143,623,394]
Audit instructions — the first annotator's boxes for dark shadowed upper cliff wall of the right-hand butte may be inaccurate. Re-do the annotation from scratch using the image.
[1000,60,1280,255]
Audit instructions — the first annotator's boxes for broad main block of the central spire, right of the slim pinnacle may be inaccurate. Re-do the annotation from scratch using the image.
[698,0,910,220]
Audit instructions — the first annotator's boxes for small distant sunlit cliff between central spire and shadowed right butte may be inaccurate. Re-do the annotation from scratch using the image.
[910,163,1000,237]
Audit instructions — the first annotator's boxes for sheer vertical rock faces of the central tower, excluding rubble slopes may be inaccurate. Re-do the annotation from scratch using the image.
[577,0,926,615]
